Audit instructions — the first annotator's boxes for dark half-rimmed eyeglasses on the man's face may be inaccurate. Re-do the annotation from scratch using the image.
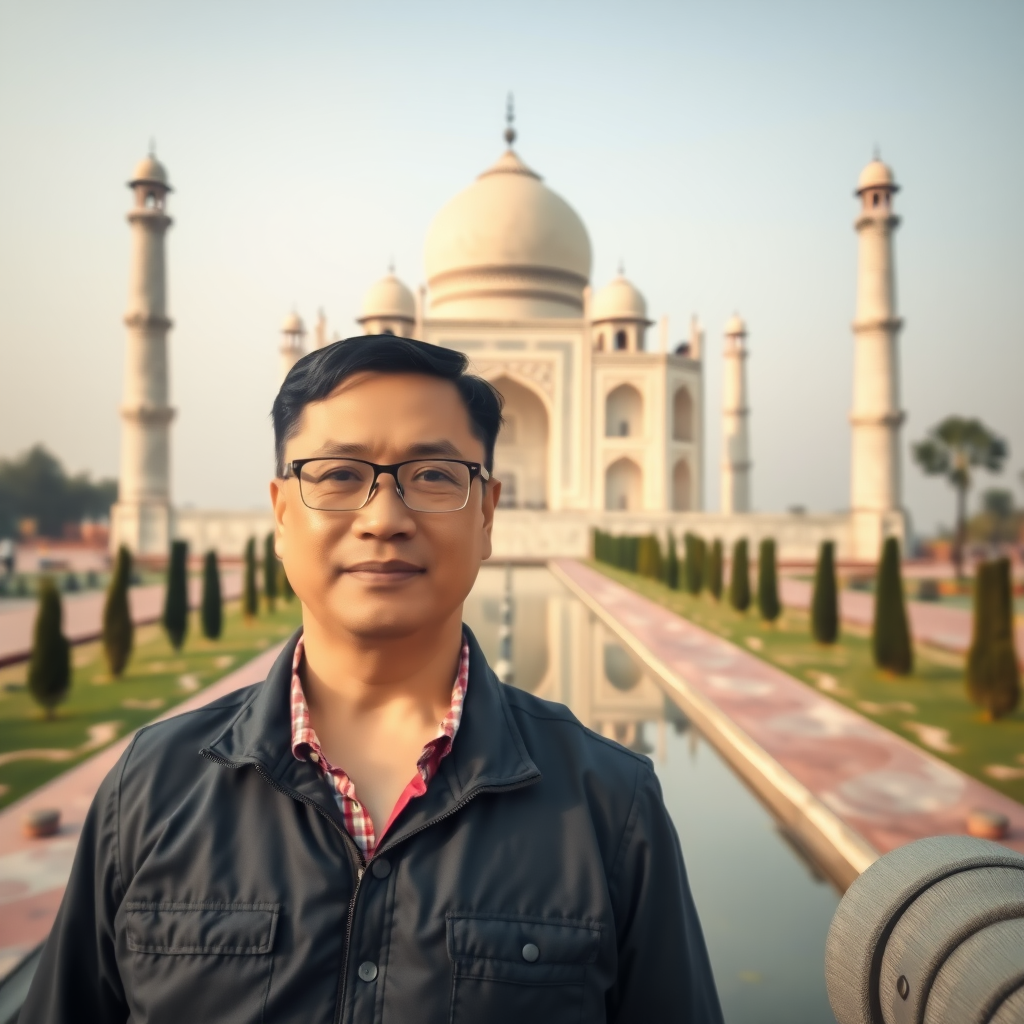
[283,459,490,512]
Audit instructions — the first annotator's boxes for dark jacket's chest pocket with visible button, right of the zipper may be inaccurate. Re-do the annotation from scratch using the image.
[447,913,601,1024]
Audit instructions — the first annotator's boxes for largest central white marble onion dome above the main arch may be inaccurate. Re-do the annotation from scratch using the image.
[425,150,591,319]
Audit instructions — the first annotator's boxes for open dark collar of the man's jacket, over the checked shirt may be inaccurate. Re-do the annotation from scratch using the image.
[203,626,541,851]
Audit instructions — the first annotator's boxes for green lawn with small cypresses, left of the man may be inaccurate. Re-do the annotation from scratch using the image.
[0,601,300,807]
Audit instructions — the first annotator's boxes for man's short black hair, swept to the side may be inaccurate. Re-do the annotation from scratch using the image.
[270,334,502,476]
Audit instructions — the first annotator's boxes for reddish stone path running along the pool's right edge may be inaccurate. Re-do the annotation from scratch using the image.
[554,559,1024,853]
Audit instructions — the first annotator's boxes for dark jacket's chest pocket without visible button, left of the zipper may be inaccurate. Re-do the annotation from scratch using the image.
[121,902,279,1024]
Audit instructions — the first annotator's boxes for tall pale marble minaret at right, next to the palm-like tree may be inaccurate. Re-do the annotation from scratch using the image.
[850,157,903,559]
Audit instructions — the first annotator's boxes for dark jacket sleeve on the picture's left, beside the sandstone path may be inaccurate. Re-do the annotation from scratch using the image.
[18,746,131,1024]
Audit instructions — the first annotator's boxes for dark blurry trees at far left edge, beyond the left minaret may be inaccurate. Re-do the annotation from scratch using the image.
[0,444,118,537]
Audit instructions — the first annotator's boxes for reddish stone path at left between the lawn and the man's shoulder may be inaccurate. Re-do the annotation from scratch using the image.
[0,644,284,979]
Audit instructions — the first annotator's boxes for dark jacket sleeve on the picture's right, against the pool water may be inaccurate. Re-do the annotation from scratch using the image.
[607,765,722,1024]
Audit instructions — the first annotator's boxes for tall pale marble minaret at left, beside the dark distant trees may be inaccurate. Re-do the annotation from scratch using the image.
[111,153,174,556]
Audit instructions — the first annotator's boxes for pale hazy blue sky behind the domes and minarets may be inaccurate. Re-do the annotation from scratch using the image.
[0,0,1024,529]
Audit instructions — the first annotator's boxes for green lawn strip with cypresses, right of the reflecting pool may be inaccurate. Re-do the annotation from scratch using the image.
[591,562,1024,803]
